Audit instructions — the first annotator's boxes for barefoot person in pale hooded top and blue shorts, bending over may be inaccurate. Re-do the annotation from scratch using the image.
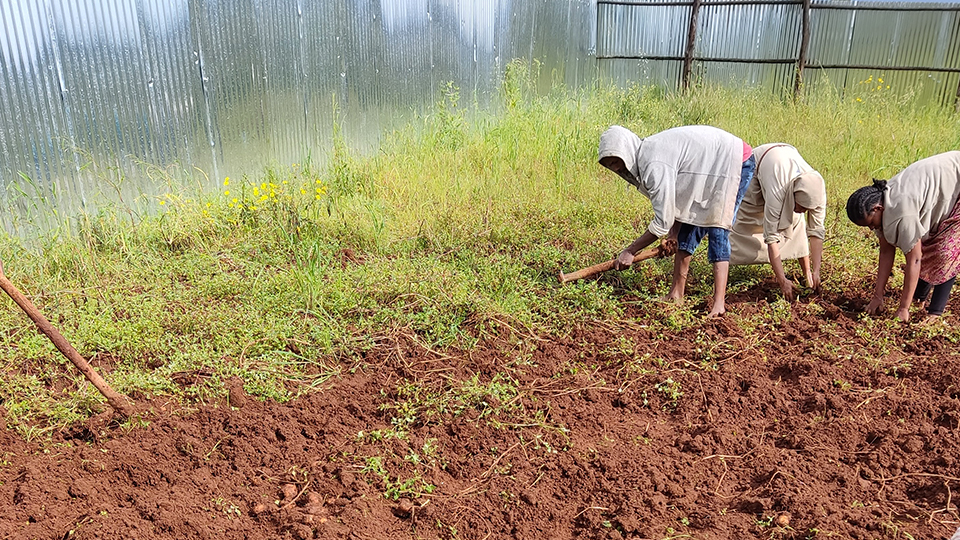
[599,126,756,317]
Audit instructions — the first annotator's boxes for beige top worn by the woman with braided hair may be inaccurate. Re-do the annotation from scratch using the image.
[878,151,960,253]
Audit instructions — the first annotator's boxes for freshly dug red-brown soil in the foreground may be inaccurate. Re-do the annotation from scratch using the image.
[0,284,960,540]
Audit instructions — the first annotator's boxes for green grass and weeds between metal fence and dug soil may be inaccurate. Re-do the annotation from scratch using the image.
[0,63,960,433]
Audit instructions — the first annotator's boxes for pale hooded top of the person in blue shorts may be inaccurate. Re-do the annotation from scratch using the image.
[599,126,743,237]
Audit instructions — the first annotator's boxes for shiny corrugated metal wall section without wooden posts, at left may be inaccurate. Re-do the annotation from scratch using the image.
[0,0,596,232]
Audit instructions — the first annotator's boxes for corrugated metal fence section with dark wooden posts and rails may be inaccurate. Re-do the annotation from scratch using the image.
[597,0,960,105]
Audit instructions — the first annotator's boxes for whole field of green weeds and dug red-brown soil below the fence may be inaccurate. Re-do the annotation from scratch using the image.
[0,65,960,540]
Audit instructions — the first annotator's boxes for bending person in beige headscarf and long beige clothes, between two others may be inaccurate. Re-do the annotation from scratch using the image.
[730,143,827,302]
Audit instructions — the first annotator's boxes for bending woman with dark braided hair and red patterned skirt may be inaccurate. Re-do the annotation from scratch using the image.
[847,151,960,321]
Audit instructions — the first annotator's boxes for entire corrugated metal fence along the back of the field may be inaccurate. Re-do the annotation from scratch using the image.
[0,0,960,233]
